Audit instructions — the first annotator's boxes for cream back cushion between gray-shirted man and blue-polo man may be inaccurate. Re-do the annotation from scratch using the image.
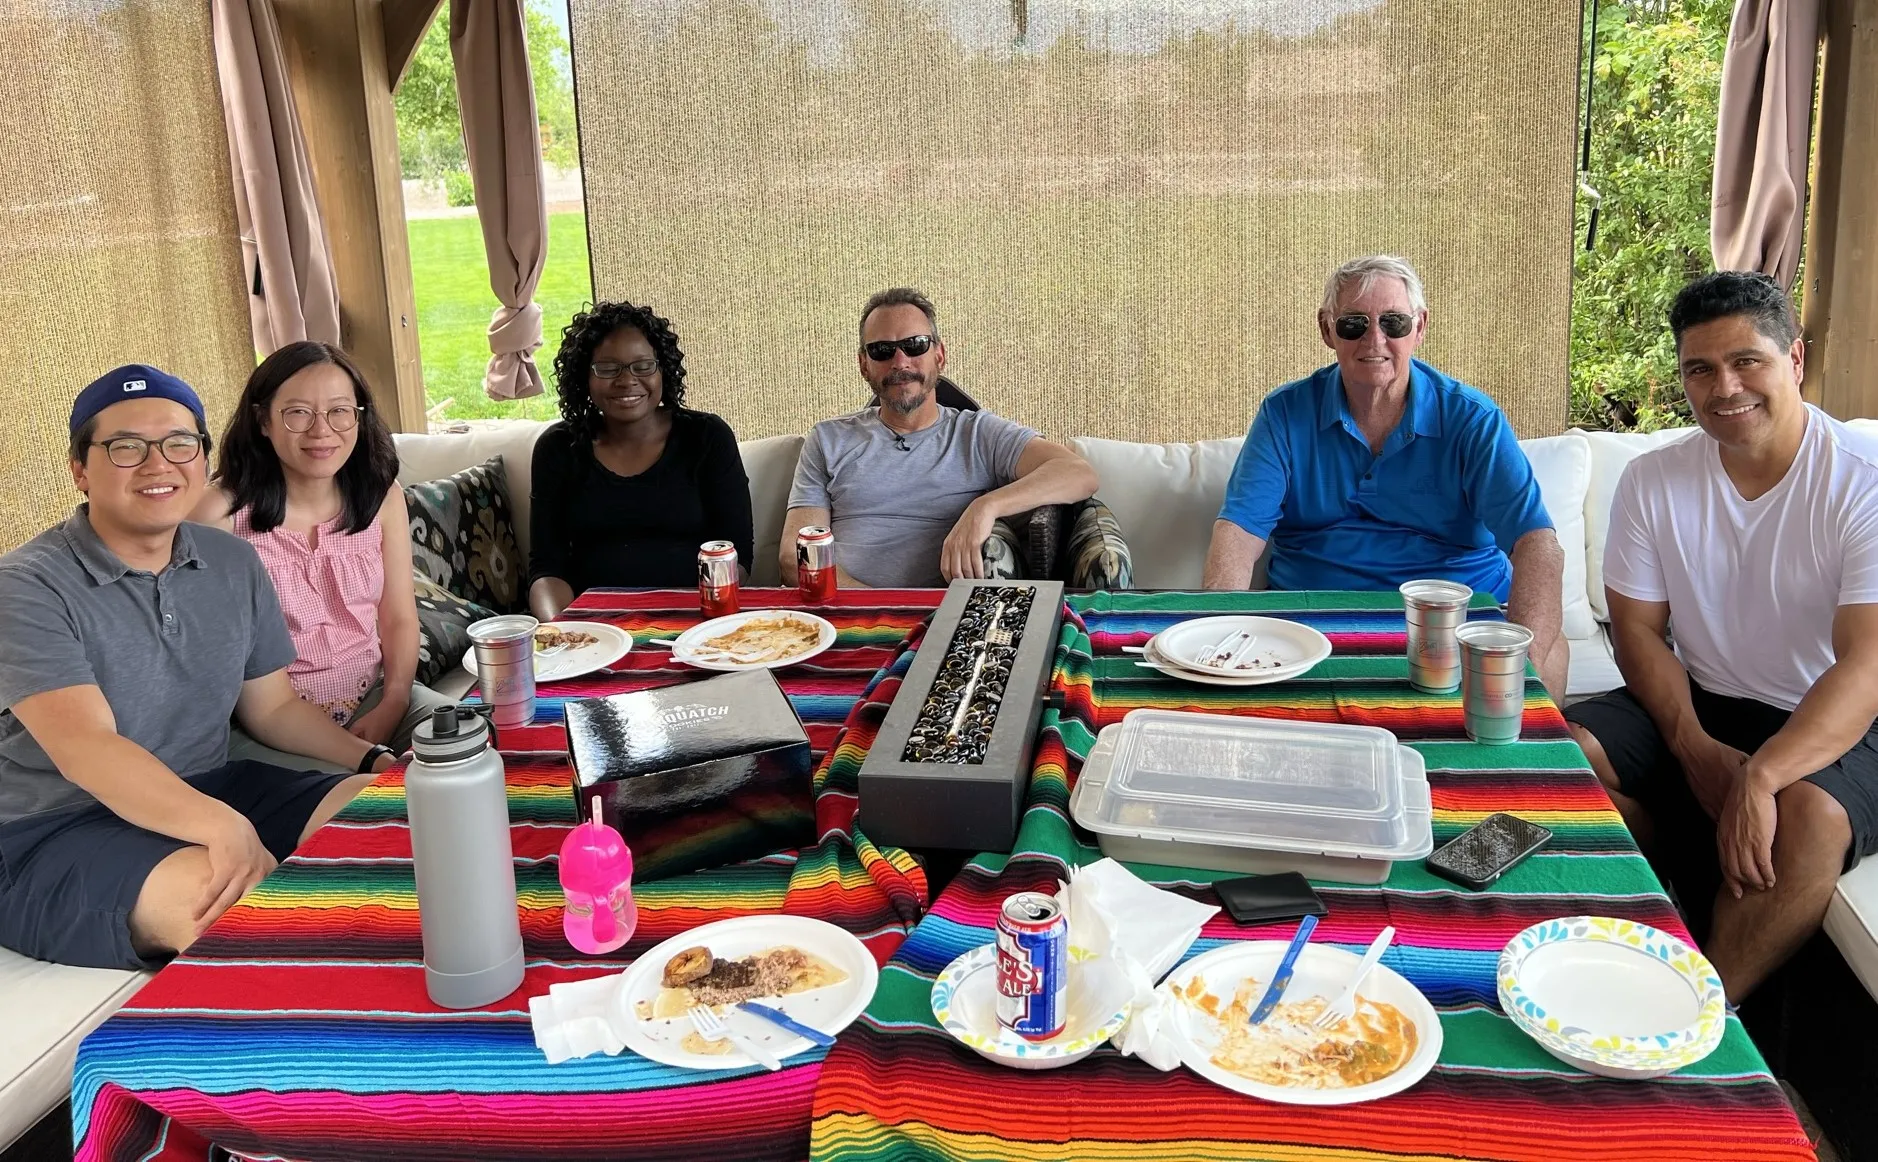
[1069,436,1245,589]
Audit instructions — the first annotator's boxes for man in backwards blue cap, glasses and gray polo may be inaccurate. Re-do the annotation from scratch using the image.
[0,364,393,967]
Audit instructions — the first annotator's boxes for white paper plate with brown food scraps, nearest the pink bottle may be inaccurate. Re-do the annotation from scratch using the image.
[616,916,881,1070]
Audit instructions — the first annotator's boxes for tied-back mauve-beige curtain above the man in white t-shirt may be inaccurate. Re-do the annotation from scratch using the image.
[1709,0,1820,289]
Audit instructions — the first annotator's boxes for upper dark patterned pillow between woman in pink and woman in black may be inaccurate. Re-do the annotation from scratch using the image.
[404,456,526,614]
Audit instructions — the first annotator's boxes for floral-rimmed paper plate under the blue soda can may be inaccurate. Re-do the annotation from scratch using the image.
[931,944,1129,1070]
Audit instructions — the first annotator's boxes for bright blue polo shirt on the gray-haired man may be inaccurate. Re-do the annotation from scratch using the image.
[1219,359,1553,601]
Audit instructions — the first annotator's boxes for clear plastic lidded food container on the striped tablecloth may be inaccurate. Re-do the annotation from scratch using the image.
[1070,710,1435,884]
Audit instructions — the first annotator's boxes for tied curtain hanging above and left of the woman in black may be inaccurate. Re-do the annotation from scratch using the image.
[451,0,548,400]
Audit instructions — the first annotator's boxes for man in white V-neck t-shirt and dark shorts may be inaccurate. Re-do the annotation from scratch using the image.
[1566,272,1878,1002]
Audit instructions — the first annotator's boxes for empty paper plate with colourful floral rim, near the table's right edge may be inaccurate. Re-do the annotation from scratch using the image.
[1499,916,1726,1079]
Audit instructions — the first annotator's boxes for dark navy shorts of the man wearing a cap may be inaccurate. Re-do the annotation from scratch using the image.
[0,762,351,969]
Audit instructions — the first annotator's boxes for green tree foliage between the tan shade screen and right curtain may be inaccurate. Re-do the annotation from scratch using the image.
[1572,0,1732,432]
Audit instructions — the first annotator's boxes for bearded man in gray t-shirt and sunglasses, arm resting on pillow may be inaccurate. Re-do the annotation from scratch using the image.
[779,287,1097,588]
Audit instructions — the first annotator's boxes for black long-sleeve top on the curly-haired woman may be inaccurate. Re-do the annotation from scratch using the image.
[528,409,755,593]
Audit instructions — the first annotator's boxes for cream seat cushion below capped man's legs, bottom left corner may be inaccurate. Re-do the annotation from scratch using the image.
[0,948,150,1149]
